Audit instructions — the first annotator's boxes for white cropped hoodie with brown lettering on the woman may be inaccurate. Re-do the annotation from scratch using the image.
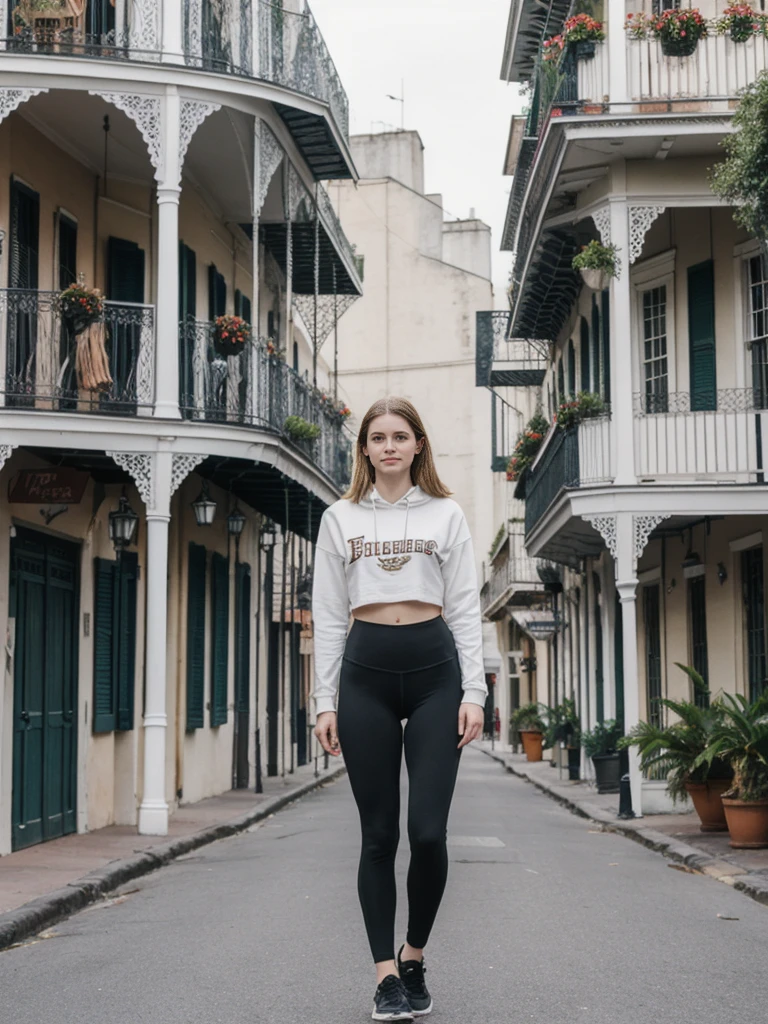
[312,486,487,715]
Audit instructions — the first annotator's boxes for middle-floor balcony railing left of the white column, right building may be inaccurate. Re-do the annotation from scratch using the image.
[525,416,614,536]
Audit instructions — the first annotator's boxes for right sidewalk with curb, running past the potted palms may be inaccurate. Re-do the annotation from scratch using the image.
[476,740,768,904]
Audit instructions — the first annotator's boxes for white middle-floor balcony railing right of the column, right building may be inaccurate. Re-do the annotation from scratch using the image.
[635,388,768,483]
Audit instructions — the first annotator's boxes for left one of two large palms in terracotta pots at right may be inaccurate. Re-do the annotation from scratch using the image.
[617,662,733,833]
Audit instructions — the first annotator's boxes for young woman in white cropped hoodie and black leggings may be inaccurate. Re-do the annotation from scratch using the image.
[312,398,487,1021]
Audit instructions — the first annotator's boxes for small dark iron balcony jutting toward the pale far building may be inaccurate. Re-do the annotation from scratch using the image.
[475,310,549,387]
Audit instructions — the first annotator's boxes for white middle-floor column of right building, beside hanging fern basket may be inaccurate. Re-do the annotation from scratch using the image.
[610,200,635,486]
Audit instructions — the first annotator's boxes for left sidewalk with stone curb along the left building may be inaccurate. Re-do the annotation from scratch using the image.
[0,760,345,950]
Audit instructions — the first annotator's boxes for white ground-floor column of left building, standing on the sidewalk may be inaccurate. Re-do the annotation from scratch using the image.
[138,452,171,836]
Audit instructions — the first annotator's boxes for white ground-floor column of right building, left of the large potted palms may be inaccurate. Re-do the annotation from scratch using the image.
[616,512,643,817]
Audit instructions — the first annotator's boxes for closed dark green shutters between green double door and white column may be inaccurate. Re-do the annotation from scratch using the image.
[93,552,138,732]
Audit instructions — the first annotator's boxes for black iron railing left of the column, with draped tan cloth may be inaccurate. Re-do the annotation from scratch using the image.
[0,289,155,416]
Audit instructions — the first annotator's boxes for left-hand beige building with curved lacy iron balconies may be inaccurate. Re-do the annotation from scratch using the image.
[0,0,361,854]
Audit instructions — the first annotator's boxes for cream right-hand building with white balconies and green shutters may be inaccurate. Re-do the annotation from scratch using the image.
[487,0,768,812]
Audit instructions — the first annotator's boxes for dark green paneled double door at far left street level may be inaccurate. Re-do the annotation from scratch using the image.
[10,527,79,850]
